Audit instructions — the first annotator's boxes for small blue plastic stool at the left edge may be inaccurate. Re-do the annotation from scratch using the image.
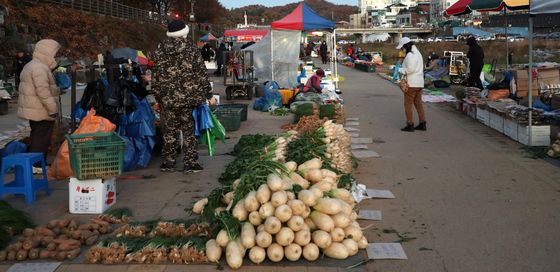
[0,153,51,204]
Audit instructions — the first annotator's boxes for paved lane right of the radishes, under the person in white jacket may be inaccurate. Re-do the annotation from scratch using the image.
[334,63,560,272]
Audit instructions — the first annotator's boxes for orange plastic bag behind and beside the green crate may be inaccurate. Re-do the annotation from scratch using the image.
[47,109,117,180]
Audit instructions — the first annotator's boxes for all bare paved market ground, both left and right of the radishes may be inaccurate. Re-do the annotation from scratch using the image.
[0,63,560,272]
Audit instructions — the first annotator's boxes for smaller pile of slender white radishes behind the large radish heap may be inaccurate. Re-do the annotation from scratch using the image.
[323,120,352,173]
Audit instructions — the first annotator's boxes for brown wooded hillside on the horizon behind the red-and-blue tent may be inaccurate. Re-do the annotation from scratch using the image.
[226,0,358,27]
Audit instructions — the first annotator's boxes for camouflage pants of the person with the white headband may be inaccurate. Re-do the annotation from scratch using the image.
[162,108,198,168]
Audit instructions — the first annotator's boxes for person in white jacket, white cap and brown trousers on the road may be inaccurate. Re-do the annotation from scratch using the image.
[397,37,426,132]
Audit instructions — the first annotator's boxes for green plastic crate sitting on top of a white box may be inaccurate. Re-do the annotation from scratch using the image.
[66,132,126,180]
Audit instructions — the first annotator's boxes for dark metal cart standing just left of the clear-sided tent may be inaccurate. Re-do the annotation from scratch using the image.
[222,50,256,100]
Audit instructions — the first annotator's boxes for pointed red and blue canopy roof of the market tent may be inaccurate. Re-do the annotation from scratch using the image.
[272,2,335,31]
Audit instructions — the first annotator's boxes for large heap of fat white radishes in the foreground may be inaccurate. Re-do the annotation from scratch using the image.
[197,159,368,269]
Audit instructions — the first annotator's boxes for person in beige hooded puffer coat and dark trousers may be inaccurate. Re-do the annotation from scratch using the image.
[18,39,60,155]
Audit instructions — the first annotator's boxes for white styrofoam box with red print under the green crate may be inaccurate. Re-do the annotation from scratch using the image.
[68,177,117,214]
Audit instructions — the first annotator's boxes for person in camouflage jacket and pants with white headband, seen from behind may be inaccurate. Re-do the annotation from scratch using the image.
[152,20,216,173]
